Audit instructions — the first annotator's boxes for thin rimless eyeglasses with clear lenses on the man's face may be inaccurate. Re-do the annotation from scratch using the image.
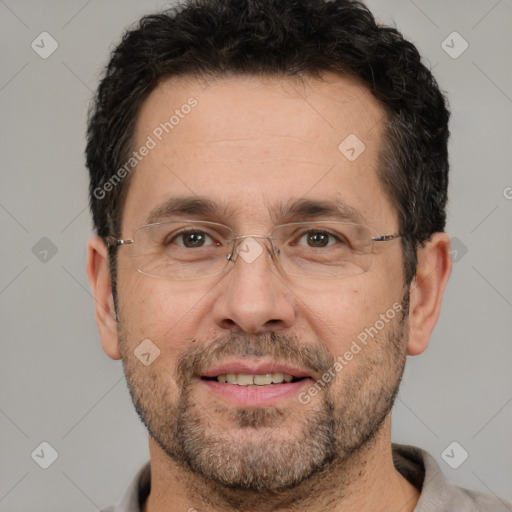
[108,220,405,280]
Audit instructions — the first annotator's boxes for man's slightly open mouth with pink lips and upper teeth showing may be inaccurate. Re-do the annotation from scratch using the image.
[199,361,315,407]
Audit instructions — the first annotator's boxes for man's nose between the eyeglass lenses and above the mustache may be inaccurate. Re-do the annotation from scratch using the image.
[213,236,296,334]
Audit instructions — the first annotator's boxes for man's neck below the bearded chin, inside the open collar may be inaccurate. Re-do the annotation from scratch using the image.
[142,416,420,512]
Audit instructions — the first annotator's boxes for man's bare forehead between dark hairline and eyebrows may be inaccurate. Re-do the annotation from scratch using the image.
[123,69,393,229]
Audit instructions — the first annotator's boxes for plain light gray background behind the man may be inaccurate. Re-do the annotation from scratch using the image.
[0,0,512,512]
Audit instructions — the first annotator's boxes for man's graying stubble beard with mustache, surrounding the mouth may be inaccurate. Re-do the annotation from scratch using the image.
[119,297,408,497]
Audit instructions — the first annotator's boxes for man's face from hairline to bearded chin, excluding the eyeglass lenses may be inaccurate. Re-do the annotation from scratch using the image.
[118,74,407,491]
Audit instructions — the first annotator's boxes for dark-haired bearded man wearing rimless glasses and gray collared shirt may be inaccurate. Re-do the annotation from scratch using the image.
[87,0,512,512]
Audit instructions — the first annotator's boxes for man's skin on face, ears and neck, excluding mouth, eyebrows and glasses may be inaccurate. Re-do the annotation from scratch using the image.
[87,73,451,512]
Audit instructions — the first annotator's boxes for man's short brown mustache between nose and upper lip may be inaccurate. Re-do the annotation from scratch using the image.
[176,332,335,385]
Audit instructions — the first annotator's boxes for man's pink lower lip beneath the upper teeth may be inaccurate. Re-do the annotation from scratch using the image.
[200,378,313,407]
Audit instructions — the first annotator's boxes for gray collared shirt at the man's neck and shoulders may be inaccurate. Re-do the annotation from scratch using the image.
[103,444,512,512]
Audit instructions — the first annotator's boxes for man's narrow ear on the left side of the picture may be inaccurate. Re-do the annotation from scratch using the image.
[87,236,121,359]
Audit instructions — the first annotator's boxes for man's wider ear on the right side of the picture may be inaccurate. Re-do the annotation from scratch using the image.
[407,233,452,356]
